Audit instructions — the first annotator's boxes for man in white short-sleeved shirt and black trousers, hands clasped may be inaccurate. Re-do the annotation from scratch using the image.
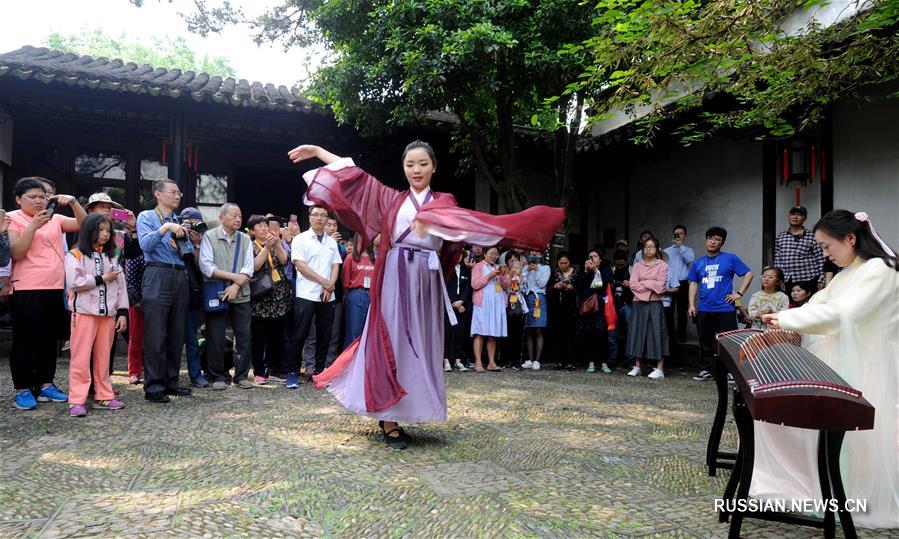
[285,206,343,389]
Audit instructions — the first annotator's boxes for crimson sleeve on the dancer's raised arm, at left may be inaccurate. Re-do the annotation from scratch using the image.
[306,166,399,250]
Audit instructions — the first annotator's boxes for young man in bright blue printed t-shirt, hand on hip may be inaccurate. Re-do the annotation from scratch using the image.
[687,226,752,380]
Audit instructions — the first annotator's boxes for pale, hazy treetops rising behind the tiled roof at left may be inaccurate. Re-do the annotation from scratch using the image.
[43,29,235,77]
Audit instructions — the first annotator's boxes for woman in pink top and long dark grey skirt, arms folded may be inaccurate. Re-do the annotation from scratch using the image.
[627,238,669,380]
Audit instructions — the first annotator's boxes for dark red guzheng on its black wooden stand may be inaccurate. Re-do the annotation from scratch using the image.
[708,329,874,538]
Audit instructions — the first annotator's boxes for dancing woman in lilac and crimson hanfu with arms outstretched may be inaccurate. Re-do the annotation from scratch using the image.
[288,141,565,449]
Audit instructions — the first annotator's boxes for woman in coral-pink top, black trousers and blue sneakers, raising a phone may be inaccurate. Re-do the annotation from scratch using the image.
[9,177,85,410]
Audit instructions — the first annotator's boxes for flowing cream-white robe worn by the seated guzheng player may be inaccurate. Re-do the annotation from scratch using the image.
[750,258,899,528]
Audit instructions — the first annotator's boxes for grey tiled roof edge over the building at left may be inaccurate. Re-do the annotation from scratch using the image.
[0,46,324,112]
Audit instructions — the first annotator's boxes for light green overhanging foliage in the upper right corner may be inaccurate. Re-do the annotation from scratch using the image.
[566,0,899,143]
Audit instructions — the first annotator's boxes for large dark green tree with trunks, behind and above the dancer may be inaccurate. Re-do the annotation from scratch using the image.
[176,0,593,213]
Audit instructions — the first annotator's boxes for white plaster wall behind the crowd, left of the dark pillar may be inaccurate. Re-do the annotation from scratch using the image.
[628,138,762,280]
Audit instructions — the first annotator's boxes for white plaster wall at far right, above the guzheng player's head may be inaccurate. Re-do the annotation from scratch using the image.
[832,99,899,248]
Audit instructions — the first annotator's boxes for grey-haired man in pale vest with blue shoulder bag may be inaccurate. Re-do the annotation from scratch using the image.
[200,203,253,390]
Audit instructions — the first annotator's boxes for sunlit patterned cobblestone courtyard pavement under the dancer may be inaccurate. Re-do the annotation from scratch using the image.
[0,359,899,538]
